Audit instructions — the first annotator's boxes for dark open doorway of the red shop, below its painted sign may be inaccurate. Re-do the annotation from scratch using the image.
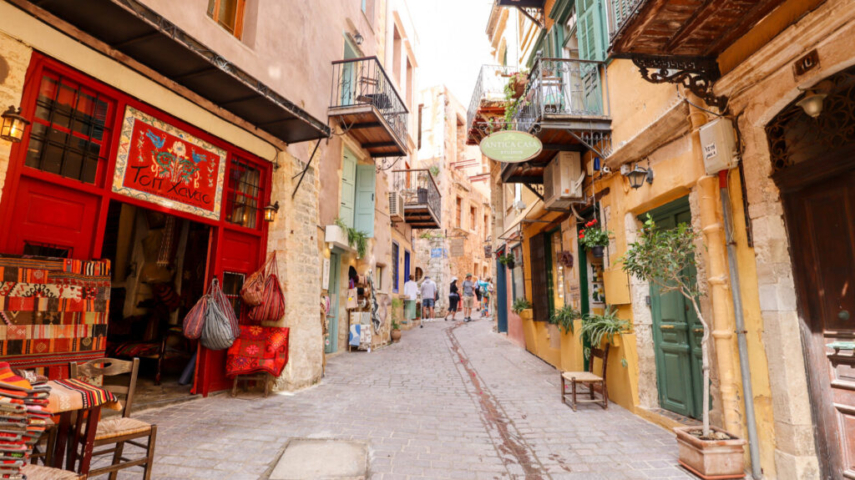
[101,201,207,407]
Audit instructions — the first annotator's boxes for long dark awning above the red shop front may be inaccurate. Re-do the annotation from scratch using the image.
[21,0,330,143]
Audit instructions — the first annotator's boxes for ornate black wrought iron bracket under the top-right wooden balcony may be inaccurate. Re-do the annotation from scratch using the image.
[630,54,727,112]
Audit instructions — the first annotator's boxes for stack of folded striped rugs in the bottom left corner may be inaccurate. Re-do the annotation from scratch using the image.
[0,362,50,480]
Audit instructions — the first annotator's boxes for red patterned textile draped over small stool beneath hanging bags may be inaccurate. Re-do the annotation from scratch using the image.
[226,325,289,377]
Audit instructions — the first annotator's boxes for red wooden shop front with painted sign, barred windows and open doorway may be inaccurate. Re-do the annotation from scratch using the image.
[0,53,275,395]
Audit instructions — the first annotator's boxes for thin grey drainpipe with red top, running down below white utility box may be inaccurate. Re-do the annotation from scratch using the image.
[718,170,763,479]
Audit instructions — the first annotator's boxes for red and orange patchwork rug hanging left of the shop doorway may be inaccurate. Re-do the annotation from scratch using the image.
[0,255,110,378]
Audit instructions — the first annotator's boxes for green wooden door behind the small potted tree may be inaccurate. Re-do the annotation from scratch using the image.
[650,198,703,418]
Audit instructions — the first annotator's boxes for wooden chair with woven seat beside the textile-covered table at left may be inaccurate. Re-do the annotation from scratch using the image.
[71,358,157,480]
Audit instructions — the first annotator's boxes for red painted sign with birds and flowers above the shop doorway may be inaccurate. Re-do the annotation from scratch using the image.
[113,107,226,220]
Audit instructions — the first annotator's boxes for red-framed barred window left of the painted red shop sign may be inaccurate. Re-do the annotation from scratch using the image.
[25,71,115,184]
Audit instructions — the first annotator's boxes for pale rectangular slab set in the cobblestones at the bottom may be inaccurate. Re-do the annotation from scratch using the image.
[261,438,368,480]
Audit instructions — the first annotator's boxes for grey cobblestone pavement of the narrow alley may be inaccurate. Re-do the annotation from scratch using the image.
[110,320,693,480]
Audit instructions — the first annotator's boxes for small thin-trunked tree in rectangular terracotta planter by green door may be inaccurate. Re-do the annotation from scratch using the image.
[621,215,745,478]
